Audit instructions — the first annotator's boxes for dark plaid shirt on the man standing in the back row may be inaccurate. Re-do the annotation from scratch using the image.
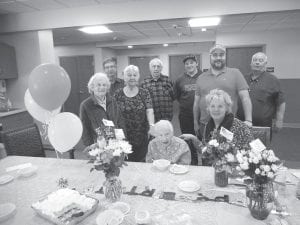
[141,74,174,122]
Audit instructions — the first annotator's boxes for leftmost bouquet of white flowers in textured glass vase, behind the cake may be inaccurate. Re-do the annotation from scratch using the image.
[88,127,132,202]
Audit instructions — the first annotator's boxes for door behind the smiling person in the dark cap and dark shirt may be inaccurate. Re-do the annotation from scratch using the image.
[169,54,201,81]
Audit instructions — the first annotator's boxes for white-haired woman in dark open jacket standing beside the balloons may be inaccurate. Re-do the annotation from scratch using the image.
[80,73,124,146]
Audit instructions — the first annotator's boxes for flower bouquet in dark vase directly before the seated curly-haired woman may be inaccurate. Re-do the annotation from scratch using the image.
[202,130,237,187]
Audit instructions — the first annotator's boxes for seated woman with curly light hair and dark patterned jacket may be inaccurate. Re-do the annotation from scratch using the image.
[180,89,254,164]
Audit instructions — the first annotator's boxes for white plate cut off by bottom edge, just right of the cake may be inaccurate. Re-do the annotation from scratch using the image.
[96,209,124,225]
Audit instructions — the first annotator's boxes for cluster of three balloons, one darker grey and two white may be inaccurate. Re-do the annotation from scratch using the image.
[24,63,82,153]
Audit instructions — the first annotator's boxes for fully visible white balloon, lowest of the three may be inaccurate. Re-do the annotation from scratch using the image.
[48,112,82,153]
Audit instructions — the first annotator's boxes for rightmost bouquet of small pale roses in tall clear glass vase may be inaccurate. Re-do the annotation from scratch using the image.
[236,148,281,220]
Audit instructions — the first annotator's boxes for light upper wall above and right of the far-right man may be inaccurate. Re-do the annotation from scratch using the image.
[216,29,300,79]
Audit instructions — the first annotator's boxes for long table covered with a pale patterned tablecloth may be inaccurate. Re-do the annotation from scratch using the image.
[0,156,300,225]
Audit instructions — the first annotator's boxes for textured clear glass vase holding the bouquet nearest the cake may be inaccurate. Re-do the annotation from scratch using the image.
[103,176,122,202]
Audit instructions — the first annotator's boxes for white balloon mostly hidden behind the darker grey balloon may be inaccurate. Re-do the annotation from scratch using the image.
[24,89,61,123]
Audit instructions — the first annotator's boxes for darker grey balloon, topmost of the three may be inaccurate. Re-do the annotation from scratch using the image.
[28,63,71,110]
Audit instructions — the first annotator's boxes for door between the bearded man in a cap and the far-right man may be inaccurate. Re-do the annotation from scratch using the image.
[226,46,263,75]
